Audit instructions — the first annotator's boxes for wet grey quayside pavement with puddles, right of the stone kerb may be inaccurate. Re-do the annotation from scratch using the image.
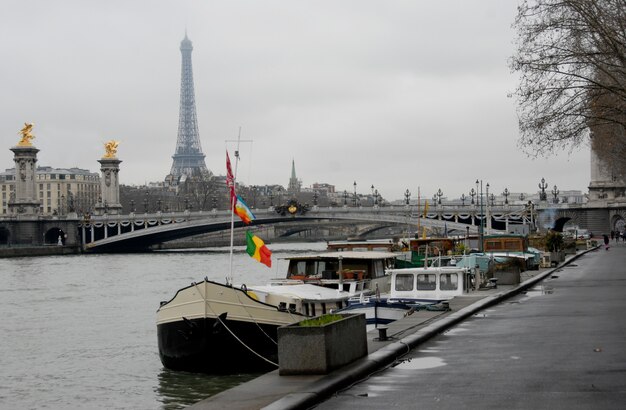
[316,242,626,410]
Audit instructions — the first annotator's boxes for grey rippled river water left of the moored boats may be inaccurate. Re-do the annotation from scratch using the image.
[0,243,325,409]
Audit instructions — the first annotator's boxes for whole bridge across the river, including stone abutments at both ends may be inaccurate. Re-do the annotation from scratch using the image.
[0,201,626,252]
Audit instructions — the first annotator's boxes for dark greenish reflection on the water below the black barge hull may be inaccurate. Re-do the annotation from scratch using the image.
[157,369,259,410]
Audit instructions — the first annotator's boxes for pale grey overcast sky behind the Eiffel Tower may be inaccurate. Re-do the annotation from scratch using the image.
[0,0,589,200]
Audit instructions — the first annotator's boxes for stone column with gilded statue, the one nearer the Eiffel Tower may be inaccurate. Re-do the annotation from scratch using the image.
[95,141,122,215]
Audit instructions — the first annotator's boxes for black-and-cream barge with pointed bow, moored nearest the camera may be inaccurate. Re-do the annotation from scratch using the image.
[157,251,395,374]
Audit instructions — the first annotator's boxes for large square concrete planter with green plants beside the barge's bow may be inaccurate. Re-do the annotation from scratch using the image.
[278,314,367,375]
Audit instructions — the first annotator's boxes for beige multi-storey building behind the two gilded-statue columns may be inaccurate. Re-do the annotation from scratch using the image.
[0,166,100,216]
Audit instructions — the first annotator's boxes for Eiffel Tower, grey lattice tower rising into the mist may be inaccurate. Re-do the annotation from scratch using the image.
[169,33,209,180]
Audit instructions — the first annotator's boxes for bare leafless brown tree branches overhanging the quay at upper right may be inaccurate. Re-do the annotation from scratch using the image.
[510,0,626,158]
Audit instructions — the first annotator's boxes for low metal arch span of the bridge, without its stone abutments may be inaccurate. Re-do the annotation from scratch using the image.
[80,206,530,252]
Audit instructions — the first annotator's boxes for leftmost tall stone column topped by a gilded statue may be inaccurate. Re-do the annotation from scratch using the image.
[8,124,40,215]
